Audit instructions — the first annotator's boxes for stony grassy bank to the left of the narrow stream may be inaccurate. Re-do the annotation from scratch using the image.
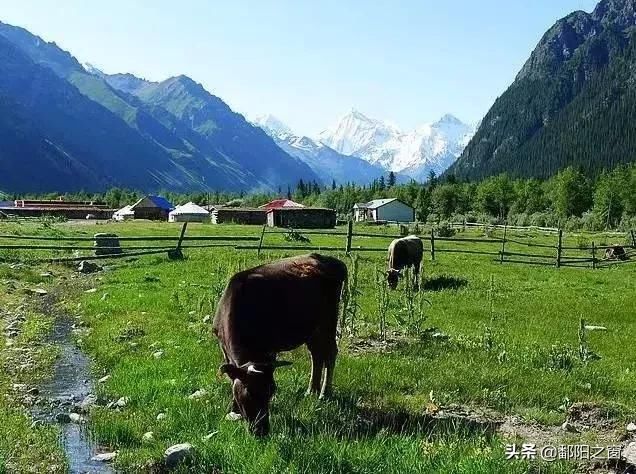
[0,265,66,473]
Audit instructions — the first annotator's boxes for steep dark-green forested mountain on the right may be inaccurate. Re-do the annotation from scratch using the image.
[448,0,636,179]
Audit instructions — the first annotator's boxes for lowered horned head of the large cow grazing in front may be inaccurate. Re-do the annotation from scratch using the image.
[221,361,291,436]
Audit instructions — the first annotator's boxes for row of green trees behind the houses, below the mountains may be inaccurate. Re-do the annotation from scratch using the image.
[6,164,636,230]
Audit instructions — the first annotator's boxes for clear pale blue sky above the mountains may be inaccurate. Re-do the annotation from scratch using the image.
[0,0,596,135]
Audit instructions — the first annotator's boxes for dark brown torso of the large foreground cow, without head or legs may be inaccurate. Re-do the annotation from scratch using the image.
[214,254,347,355]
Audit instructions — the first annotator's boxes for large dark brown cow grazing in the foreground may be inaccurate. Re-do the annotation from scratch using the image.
[214,254,347,435]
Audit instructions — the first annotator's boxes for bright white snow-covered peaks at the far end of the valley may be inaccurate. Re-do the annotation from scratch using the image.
[318,109,474,179]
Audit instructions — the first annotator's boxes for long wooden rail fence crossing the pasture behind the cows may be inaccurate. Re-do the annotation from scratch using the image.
[0,221,636,268]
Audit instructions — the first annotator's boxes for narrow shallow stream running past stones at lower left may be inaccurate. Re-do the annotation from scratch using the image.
[34,317,115,474]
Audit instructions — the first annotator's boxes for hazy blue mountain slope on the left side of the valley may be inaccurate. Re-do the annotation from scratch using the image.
[0,19,319,192]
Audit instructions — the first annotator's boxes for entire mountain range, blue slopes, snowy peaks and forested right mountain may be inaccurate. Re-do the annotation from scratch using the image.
[0,0,636,193]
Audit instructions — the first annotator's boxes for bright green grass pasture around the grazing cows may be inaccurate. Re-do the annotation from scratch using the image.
[0,222,636,473]
